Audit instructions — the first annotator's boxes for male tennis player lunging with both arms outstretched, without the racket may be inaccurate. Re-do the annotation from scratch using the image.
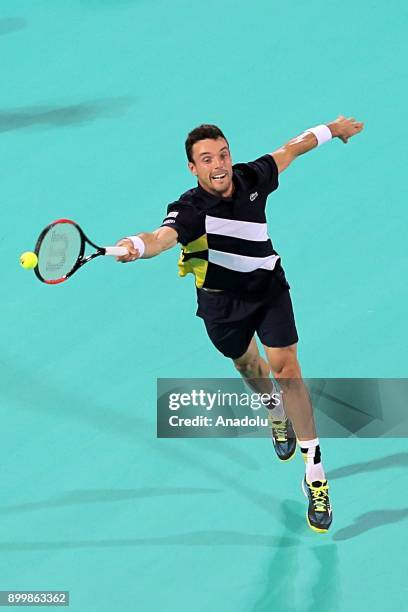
[117,115,363,532]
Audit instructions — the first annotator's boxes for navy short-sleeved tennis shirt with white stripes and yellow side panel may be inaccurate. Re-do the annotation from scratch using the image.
[162,155,283,293]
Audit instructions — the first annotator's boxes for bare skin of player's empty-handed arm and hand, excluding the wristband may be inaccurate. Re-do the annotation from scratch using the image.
[271,115,364,172]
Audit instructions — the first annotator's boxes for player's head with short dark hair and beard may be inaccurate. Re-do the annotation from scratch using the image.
[186,124,233,197]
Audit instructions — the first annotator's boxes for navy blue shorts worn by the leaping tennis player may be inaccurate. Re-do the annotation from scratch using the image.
[197,272,298,359]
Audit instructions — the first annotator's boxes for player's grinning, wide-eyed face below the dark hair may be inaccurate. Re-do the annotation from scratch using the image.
[188,138,233,198]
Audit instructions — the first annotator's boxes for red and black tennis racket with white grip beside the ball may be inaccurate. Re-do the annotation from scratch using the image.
[34,219,128,285]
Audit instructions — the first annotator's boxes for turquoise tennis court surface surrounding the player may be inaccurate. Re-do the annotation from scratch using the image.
[0,0,408,612]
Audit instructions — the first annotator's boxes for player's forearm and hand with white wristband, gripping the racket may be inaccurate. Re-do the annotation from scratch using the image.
[116,227,177,263]
